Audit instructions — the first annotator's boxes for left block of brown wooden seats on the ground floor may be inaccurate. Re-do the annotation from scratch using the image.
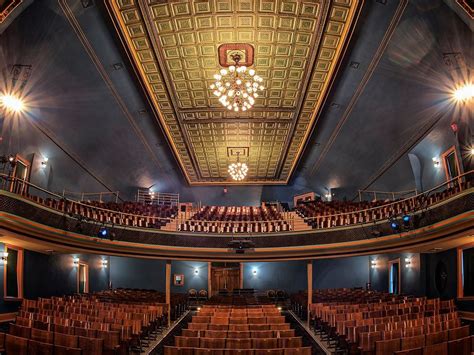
[0,290,172,355]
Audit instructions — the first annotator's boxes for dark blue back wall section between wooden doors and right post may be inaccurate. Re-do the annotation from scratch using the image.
[243,260,308,292]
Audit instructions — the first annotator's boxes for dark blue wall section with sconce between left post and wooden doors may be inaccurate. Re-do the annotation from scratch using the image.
[171,261,208,293]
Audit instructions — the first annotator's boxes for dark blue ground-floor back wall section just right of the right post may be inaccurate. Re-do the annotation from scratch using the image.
[313,256,369,289]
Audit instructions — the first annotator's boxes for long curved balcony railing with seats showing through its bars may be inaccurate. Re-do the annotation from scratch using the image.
[0,171,474,235]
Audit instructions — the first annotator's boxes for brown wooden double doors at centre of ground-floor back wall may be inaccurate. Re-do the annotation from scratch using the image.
[210,263,241,296]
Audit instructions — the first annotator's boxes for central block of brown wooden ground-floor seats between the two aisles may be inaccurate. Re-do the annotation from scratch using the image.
[165,304,312,355]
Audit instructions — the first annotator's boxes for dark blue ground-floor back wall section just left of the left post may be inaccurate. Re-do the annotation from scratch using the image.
[110,256,166,291]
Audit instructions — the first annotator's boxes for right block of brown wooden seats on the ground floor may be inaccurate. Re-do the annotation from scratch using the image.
[293,289,468,355]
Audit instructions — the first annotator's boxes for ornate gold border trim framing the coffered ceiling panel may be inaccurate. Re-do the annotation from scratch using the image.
[106,0,362,186]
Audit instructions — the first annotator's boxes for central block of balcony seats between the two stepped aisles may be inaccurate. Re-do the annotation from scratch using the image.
[179,205,291,233]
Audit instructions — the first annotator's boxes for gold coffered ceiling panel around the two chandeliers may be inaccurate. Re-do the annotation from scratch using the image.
[108,0,361,185]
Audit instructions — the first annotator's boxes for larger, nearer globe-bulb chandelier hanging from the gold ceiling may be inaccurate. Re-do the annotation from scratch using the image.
[210,54,265,112]
